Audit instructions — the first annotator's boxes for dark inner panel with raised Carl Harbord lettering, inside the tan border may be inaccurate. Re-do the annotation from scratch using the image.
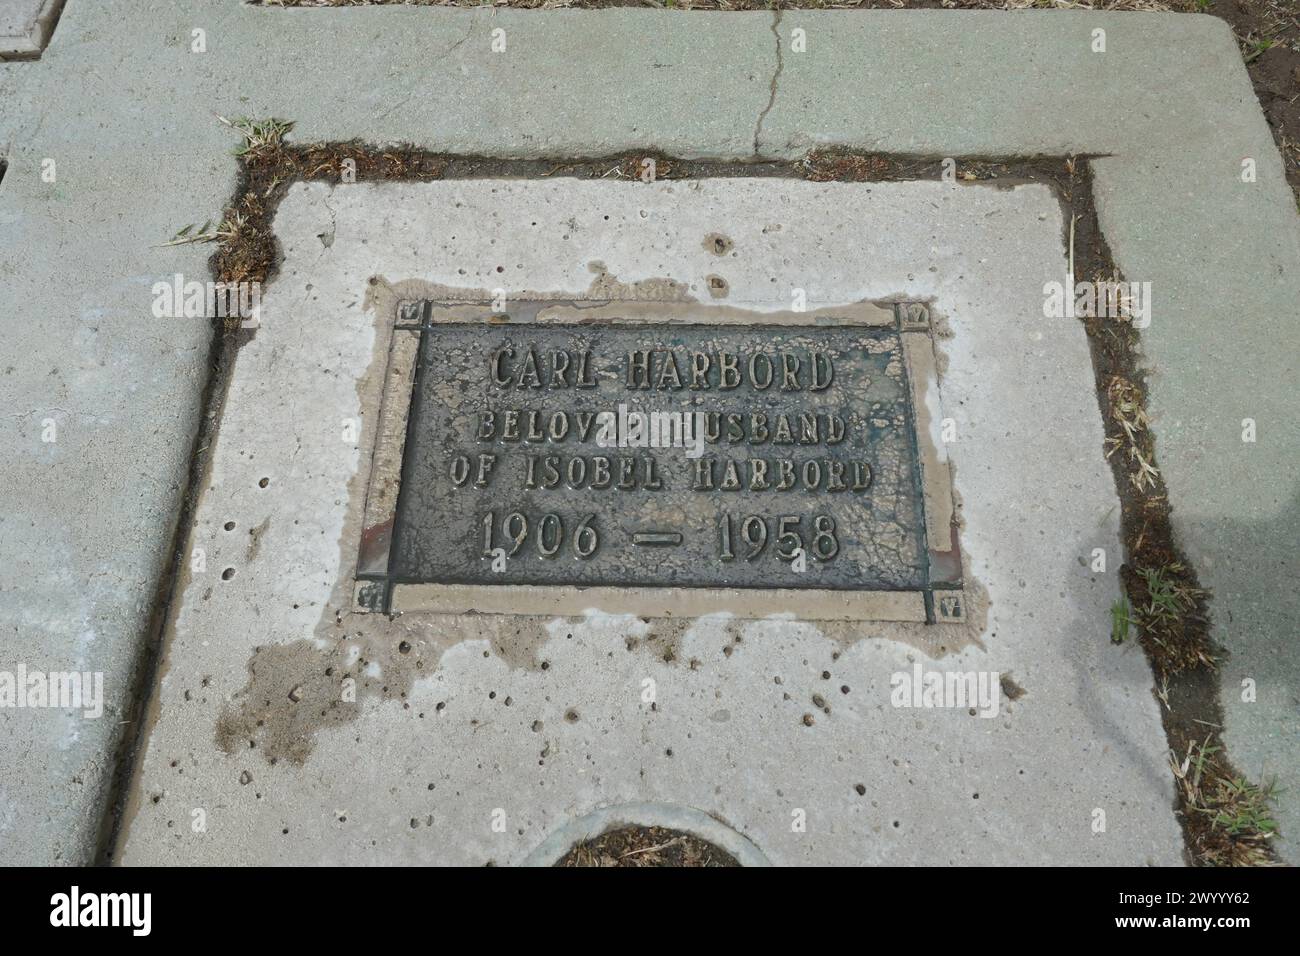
[359,303,948,619]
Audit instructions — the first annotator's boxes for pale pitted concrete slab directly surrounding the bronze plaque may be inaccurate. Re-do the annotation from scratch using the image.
[114,179,1182,865]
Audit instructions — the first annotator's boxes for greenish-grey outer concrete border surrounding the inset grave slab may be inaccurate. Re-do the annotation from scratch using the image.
[0,0,1300,862]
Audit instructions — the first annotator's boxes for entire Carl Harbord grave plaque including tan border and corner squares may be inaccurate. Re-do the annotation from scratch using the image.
[356,300,965,623]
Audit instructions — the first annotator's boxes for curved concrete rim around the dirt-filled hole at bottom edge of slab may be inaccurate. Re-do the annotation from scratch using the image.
[521,803,772,866]
